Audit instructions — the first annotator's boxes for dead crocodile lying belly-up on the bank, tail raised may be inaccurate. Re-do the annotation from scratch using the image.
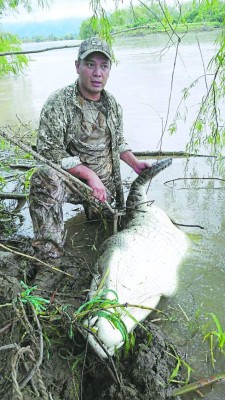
[83,158,189,358]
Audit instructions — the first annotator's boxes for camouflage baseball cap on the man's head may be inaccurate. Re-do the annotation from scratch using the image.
[78,37,112,62]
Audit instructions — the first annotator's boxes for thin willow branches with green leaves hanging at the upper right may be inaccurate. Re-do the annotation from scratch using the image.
[90,0,225,158]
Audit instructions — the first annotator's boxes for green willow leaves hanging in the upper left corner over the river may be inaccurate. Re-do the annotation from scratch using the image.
[0,0,48,77]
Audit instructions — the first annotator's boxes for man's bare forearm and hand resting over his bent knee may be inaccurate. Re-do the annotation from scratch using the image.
[67,164,107,203]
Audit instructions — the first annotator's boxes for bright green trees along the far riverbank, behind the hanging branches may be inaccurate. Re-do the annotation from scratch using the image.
[79,0,225,39]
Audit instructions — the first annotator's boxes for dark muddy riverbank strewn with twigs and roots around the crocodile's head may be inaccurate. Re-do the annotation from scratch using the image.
[0,213,184,400]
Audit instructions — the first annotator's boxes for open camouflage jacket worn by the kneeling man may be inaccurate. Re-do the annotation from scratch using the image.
[37,82,130,207]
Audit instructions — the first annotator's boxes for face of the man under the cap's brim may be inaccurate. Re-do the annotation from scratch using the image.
[75,52,111,100]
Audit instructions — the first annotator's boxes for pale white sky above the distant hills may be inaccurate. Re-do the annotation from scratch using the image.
[1,0,138,23]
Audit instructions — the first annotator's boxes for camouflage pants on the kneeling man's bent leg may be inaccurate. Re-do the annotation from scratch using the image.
[29,167,113,249]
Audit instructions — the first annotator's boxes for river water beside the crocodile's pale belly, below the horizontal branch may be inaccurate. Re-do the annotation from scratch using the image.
[146,158,225,400]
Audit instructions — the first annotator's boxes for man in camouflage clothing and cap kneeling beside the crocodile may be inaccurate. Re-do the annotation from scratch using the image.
[30,38,149,258]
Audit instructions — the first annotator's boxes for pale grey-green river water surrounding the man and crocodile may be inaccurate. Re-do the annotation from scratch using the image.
[0,32,225,400]
